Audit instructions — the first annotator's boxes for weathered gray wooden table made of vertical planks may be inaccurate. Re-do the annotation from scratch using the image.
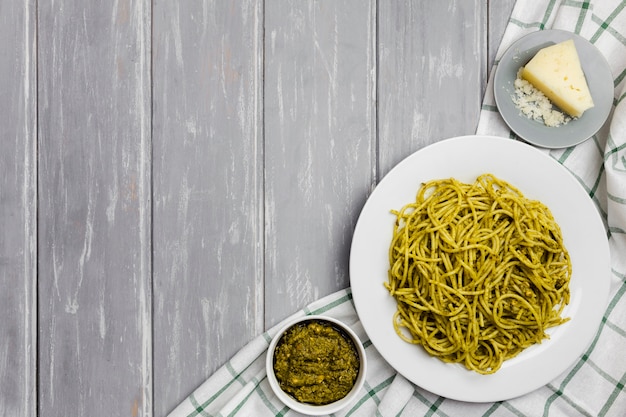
[0,0,514,416]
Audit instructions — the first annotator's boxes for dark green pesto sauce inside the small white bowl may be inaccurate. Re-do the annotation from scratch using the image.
[274,320,360,405]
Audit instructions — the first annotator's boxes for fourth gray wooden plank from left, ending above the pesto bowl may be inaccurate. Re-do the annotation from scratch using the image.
[265,0,376,327]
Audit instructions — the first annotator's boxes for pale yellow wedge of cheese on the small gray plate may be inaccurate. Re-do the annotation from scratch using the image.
[521,39,593,117]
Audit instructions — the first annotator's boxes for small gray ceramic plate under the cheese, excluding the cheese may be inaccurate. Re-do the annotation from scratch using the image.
[494,30,613,148]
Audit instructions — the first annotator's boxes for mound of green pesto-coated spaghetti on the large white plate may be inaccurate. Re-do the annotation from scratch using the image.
[385,174,572,374]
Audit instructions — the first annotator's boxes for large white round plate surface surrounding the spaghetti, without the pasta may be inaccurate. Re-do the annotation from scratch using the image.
[350,136,610,402]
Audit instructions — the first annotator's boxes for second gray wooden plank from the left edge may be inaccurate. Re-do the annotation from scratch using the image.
[38,0,152,416]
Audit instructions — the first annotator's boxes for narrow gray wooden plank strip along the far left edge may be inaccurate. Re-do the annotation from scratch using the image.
[0,1,37,417]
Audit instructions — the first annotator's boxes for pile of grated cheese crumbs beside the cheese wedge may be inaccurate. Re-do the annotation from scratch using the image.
[512,73,572,127]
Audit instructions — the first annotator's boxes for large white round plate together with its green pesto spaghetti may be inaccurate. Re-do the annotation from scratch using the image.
[350,136,610,402]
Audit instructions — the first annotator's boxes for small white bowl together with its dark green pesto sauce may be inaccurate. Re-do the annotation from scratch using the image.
[266,315,367,415]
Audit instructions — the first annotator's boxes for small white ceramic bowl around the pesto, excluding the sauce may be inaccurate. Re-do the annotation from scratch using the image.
[265,315,367,416]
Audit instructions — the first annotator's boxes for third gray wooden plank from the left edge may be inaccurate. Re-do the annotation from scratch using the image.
[153,0,264,415]
